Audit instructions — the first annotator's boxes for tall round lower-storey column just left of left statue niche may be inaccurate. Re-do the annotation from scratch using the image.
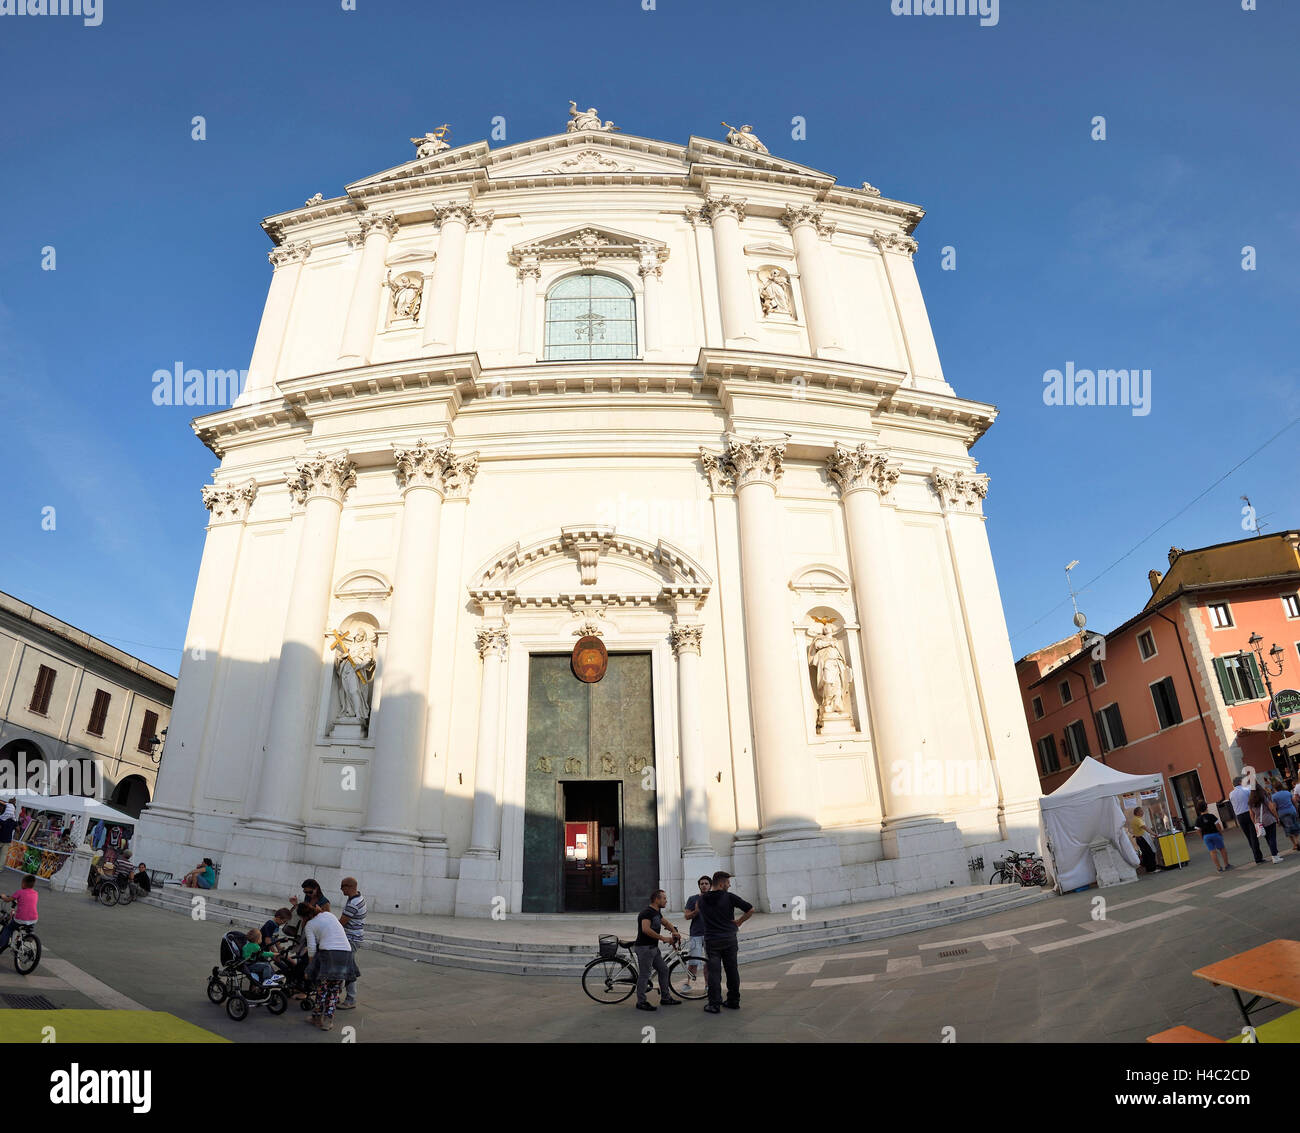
[250,451,356,835]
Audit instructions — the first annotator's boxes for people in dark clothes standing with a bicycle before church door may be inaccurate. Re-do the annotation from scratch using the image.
[632,869,754,1015]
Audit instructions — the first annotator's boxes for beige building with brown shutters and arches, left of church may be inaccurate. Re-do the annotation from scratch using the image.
[0,594,176,815]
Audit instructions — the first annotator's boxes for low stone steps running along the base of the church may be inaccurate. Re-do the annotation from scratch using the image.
[142,886,1048,977]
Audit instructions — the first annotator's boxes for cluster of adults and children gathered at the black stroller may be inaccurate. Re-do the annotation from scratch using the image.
[232,877,367,1030]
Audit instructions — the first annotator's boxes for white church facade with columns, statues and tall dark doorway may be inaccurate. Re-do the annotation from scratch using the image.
[142,105,1039,916]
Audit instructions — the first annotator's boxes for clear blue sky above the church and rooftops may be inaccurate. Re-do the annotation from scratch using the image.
[0,0,1300,672]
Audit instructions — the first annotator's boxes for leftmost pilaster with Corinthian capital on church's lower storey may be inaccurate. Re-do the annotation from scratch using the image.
[148,479,257,821]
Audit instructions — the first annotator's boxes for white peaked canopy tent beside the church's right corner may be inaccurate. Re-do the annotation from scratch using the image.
[1039,756,1164,893]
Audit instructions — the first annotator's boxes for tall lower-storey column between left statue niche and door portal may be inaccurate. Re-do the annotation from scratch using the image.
[361,440,477,843]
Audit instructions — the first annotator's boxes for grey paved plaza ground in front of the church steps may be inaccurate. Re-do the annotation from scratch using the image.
[0,832,1300,1042]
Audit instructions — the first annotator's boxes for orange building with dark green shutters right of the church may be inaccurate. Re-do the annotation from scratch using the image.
[1015,531,1300,826]
